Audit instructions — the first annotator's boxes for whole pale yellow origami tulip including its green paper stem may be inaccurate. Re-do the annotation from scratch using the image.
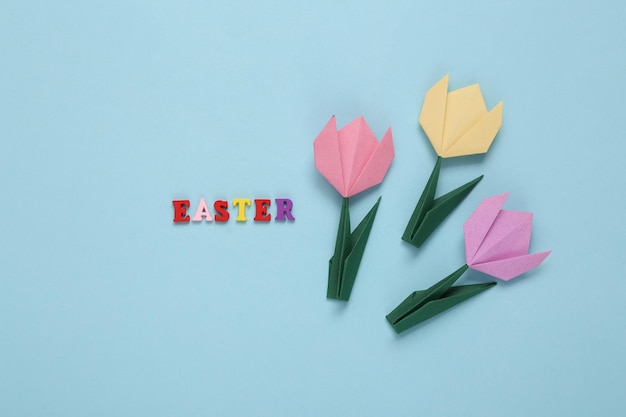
[402,75,502,248]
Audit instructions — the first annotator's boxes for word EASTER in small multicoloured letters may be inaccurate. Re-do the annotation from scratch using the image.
[172,198,296,223]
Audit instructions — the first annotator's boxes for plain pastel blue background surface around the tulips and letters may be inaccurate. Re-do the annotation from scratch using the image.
[0,0,626,417]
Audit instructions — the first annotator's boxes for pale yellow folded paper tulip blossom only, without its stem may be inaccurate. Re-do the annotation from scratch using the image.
[419,75,502,158]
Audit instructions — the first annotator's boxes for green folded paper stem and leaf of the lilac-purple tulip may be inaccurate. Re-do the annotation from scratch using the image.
[387,265,496,333]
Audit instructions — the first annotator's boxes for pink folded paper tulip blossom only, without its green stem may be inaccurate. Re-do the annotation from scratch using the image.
[313,116,394,198]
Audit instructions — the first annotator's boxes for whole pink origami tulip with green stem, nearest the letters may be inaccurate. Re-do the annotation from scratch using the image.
[313,116,394,301]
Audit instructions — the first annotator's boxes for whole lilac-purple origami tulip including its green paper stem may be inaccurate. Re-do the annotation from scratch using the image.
[387,193,550,333]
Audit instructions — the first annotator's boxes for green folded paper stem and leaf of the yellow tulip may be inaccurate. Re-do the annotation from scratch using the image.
[402,156,483,248]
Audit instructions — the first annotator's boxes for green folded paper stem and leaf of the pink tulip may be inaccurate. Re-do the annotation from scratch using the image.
[326,197,381,301]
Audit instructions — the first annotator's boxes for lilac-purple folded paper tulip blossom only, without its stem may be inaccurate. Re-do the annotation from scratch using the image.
[463,193,550,281]
